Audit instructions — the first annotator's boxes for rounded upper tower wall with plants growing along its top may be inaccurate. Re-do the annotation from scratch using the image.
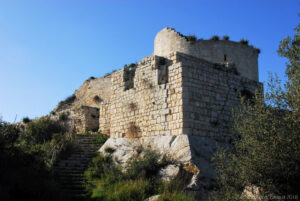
[153,28,259,81]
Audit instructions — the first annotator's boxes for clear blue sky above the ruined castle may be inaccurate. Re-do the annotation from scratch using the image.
[0,0,300,122]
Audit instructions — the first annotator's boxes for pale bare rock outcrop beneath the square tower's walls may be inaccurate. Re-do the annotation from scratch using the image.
[99,135,226,199]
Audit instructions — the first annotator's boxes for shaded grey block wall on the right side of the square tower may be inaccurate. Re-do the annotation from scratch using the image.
[176,53,262,142]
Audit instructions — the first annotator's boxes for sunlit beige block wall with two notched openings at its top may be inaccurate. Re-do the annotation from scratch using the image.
[100,56,183,137]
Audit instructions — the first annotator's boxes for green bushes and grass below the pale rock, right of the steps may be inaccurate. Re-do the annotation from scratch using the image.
[85,149,192,201]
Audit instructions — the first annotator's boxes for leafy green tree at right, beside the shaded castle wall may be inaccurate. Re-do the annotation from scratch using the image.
[214,22,300,200]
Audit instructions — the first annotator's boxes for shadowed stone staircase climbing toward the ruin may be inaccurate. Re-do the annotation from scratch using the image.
[53,134,99,200]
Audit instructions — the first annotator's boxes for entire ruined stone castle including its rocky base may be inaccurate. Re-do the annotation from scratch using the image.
[54,28,262,200]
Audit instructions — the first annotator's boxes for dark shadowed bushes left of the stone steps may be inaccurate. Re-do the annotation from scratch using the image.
[0,121,67,201]
